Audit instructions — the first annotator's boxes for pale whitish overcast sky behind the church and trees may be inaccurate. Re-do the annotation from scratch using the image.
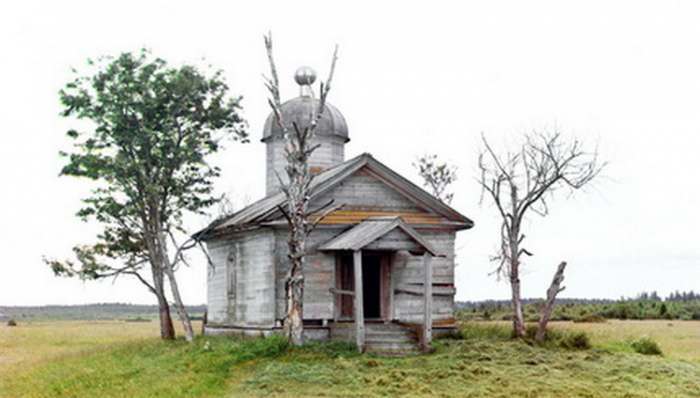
[0,0,700,305]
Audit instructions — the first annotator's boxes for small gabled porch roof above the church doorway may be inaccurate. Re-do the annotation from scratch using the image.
[319,217,439,256]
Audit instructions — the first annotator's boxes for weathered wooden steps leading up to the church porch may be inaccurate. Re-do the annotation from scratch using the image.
[330,322,420,356]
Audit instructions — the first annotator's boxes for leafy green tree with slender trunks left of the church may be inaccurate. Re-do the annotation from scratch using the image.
[45,50,247,340]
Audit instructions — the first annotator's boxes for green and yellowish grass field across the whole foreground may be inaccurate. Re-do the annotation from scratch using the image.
[0,321,700,397]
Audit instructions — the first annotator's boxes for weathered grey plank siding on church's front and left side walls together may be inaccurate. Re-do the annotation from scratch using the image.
[213,166,462,327]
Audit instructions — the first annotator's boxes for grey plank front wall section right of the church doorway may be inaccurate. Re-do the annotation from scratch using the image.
[393,230,455,323]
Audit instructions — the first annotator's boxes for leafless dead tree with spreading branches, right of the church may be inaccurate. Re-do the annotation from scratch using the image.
[479,130,606,337]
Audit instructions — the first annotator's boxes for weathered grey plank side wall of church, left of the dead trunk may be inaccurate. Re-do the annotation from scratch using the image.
[207,229,276,327]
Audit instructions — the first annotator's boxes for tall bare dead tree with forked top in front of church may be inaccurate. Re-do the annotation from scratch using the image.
[264,34,338,345]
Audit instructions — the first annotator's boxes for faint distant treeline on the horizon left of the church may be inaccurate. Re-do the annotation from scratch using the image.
[0,303,207,320]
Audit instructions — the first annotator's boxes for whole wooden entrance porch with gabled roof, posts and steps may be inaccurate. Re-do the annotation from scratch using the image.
[319,217,437,352]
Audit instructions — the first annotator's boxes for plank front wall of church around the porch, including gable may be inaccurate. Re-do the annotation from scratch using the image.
[275,166,455,321]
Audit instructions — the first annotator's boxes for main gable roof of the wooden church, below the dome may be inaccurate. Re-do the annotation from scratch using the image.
[194,153,474,240]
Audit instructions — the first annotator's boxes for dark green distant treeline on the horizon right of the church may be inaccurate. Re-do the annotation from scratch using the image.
[457,291,700,322]
